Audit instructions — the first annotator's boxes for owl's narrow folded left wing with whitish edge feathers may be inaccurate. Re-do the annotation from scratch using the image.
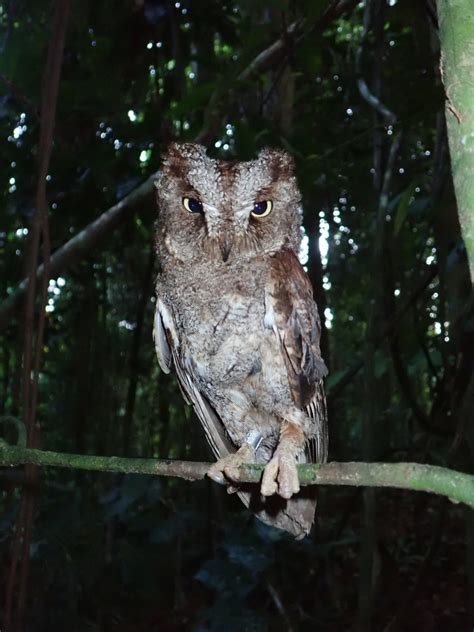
[153,298,235,457]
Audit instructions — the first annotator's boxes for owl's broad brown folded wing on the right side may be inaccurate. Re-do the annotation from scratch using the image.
[265,249,327,461]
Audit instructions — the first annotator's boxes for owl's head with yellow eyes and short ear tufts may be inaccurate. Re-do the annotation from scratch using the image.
[156,143,301,263]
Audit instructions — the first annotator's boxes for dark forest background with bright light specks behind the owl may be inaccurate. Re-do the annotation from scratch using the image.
[0,0,474,632]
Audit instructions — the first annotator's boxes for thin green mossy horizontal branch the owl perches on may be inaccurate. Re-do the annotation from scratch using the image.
[0,439,474,508]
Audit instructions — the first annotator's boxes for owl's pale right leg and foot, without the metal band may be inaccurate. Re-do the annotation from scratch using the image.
[260,421,306,498]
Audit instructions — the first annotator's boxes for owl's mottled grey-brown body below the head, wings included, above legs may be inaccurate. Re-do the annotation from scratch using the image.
[155,249,326,440]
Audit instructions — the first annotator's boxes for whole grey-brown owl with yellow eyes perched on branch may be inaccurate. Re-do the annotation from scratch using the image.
[154,143,327,538]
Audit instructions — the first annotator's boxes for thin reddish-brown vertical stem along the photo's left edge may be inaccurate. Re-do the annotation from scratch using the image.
[3,0,69,632]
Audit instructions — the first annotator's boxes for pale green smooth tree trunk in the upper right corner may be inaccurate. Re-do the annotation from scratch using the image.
[438,0,474,280]
